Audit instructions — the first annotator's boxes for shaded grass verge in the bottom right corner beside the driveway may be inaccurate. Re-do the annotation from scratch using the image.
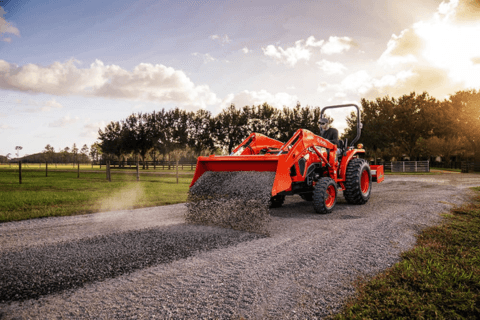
[334,187,480,319]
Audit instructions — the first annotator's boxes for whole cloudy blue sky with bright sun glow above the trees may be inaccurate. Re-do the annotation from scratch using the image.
[0,0,480,157]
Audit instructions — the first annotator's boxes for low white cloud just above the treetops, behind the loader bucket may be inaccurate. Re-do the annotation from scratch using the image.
[221,89,298,108]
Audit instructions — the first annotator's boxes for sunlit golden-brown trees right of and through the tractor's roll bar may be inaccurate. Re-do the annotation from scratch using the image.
[344,90,480,163]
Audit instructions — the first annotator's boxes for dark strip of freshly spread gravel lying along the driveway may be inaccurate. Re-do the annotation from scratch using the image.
[0,225,261,302]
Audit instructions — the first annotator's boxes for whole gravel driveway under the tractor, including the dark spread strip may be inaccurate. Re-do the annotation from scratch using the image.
[0,174,480,319]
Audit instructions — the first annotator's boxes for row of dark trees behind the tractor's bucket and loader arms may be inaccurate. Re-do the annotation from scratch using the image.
[99,103,321,169]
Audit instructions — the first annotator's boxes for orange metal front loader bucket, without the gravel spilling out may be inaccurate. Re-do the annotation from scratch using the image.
[190,154,292,197]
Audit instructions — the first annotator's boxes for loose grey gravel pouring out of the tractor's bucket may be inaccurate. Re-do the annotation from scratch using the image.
[185,171,275,234]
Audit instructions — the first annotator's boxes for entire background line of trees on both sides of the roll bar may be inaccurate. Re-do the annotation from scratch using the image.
[96,90,480,163]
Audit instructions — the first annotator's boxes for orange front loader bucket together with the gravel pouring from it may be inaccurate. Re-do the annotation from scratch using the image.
[185,154,291,234]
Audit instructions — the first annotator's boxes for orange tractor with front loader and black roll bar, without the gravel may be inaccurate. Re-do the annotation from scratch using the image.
[190,104,384,213]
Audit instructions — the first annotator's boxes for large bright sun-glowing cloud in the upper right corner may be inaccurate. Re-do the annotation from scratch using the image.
[378,0,480,97]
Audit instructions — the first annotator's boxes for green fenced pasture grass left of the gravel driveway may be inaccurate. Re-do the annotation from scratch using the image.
[0,165,193,222]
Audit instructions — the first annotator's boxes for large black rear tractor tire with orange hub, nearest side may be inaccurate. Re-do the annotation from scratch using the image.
[343,159,372,204]
